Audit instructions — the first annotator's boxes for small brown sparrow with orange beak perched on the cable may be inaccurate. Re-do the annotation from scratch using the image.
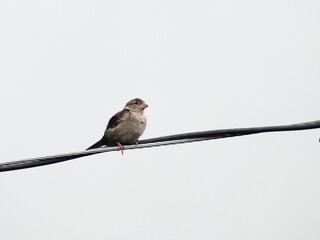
[87,98,148,154]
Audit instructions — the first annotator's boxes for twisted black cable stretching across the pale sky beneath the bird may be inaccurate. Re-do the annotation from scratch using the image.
[0,120,320,172]
